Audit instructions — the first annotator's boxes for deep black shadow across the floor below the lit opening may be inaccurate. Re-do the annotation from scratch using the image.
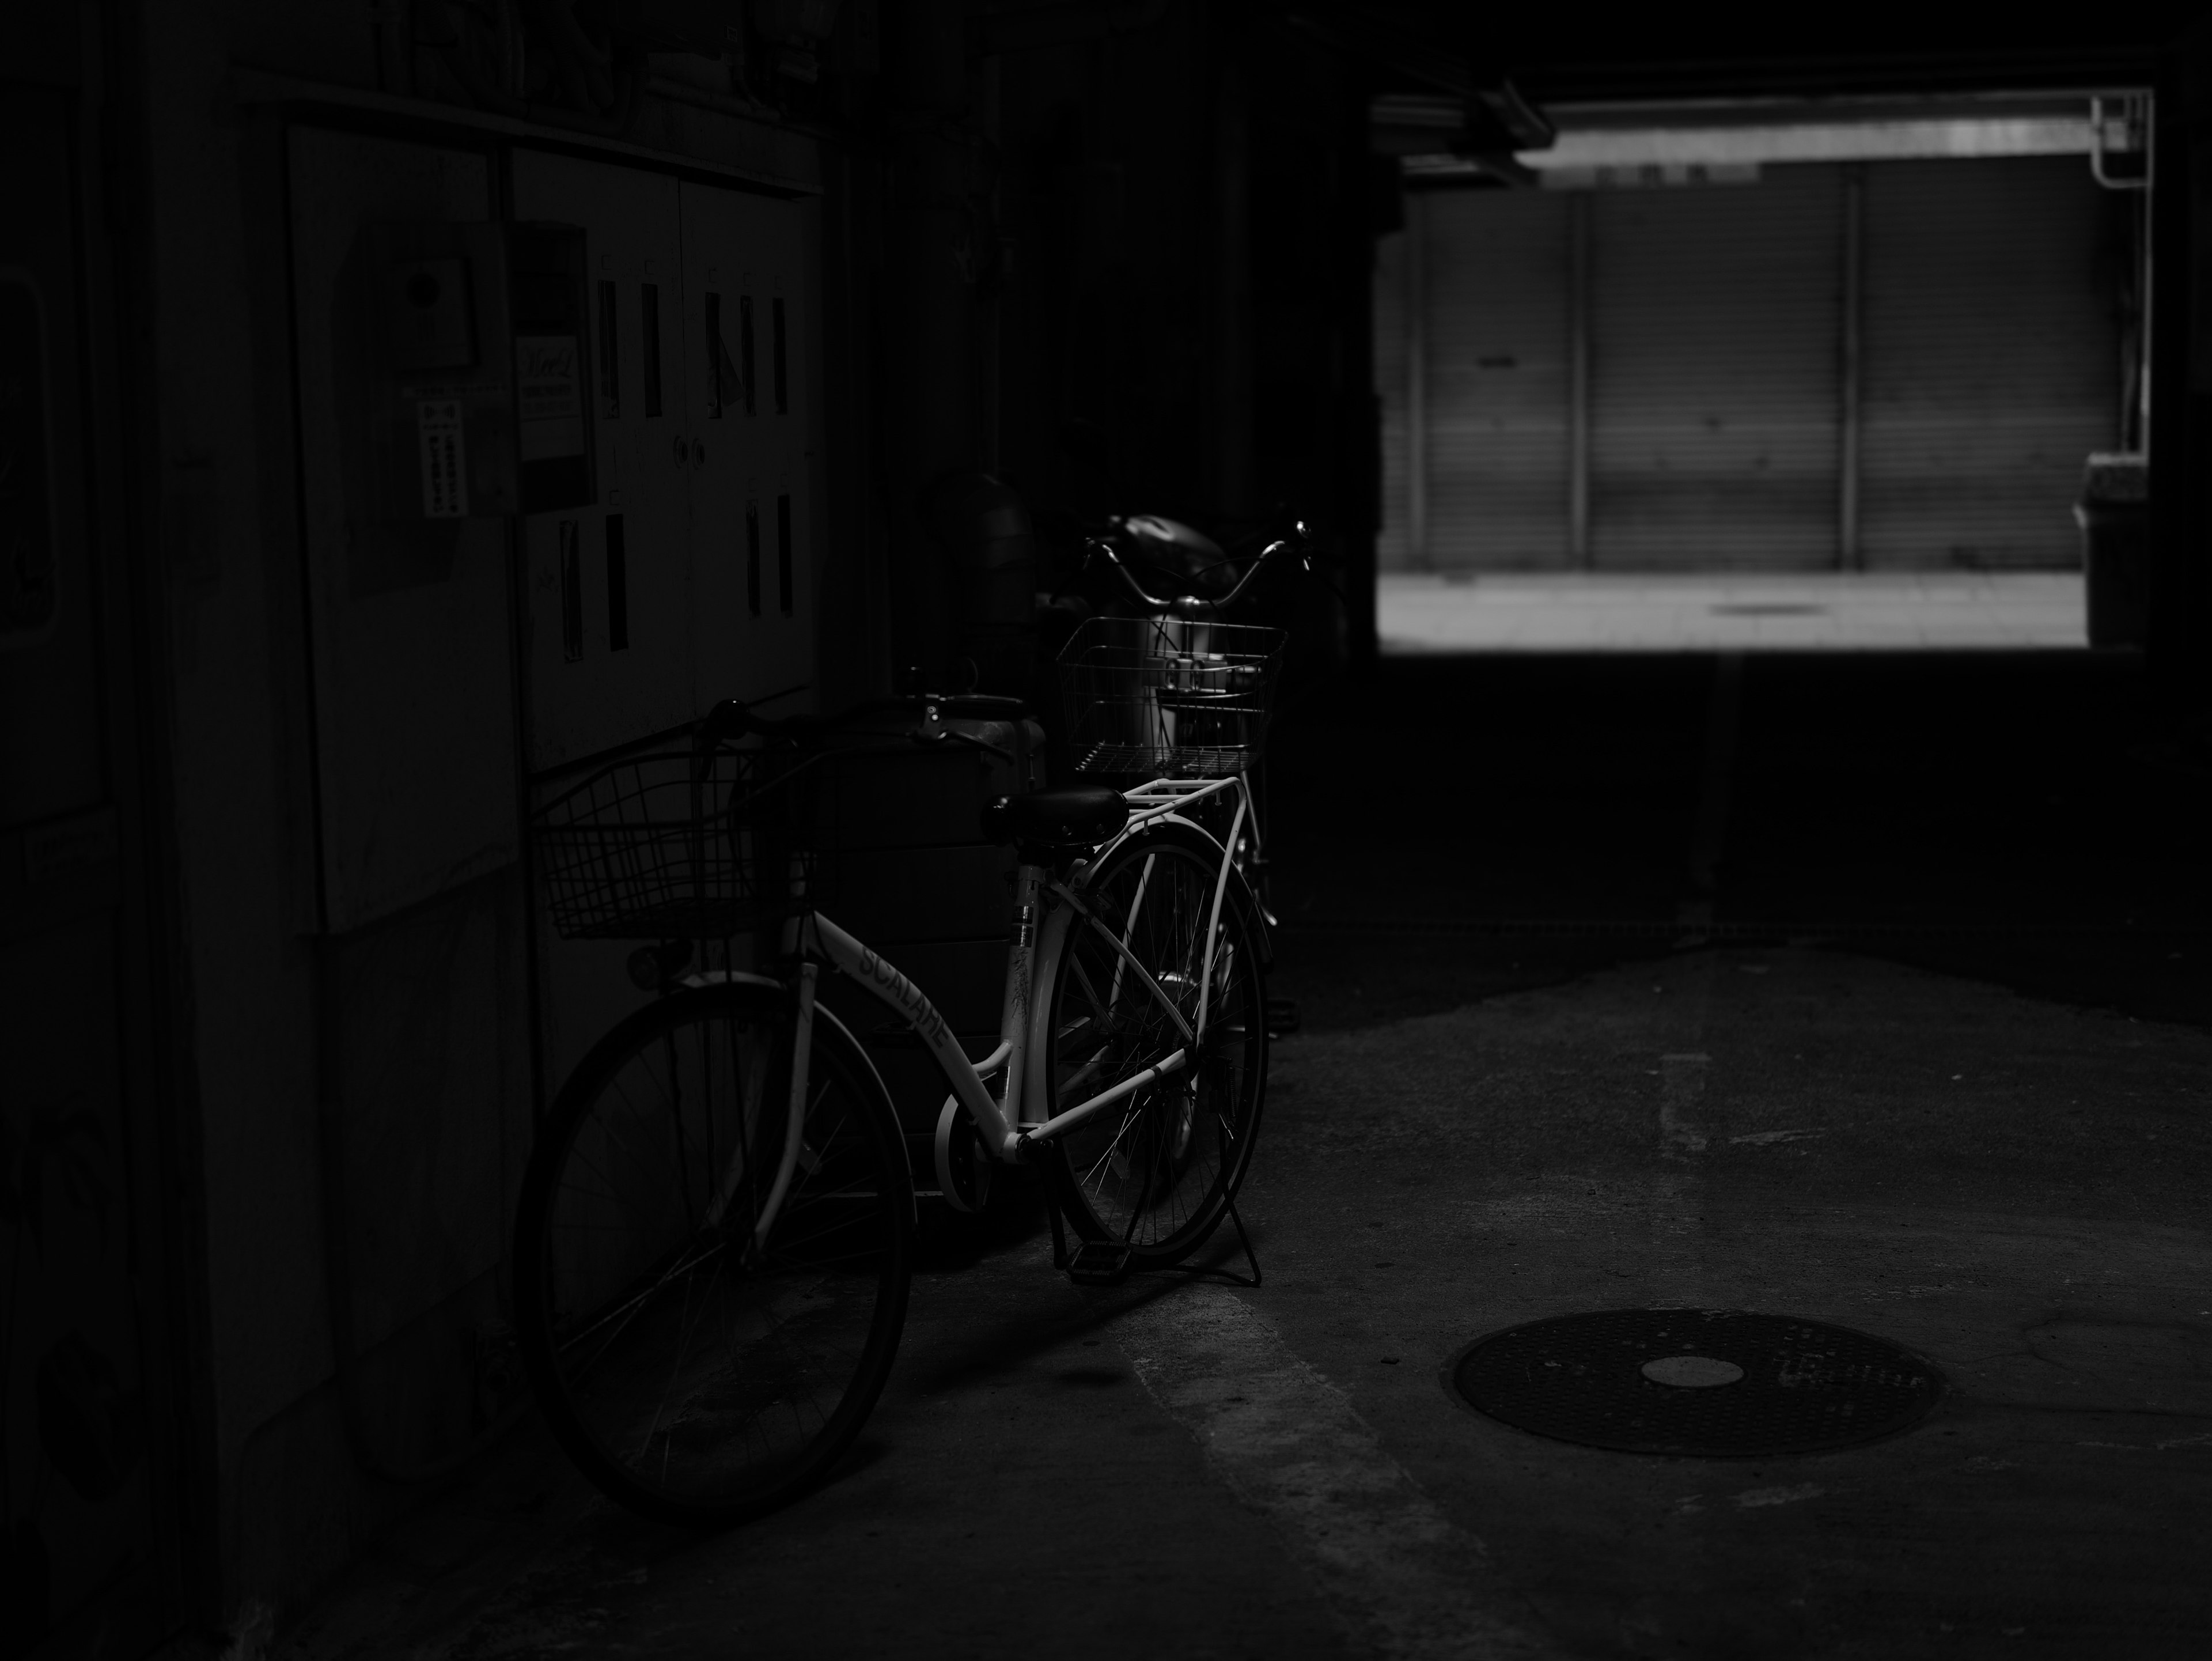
[1270,652,2212,1028]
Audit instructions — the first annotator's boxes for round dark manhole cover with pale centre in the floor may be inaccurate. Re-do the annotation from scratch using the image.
[1451,1310,1942,1458]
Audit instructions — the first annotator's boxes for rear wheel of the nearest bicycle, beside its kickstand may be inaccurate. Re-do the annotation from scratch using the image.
[1040,823,1267,1270]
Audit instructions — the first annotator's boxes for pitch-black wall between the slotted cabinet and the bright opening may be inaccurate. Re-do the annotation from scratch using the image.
[850,5,1376,690]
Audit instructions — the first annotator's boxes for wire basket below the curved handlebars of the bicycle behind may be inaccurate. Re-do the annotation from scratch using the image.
[1059,617,1287,778]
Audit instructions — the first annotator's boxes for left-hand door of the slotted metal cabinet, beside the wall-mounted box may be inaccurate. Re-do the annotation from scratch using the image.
[513,150,701,772]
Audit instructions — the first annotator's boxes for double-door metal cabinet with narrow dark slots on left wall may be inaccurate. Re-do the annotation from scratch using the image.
[513,150,819,772]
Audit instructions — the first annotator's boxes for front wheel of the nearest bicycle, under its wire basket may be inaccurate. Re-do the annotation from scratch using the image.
[516,984,914,1526]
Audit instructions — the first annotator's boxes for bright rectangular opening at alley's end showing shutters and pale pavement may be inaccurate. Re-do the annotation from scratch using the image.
[1376,93,2148,652]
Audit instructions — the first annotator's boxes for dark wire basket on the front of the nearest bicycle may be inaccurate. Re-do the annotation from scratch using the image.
[531,748,836,940]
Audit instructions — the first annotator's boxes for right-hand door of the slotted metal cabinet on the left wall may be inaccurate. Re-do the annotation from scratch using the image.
[684,184,819,712]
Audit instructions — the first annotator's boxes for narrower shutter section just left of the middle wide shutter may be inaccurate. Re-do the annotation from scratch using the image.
[1409,190,1573,570]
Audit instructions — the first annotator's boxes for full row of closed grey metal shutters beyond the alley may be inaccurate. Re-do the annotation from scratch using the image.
[1376,157,2126,570]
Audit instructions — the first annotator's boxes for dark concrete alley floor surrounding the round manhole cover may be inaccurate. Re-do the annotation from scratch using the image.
[274,654,2212,1661]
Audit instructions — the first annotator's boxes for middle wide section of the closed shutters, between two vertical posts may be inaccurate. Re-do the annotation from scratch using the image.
[1590,166,1843,570]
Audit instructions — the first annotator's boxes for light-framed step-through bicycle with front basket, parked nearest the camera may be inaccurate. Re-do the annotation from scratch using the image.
[516,553,1281,1526]
